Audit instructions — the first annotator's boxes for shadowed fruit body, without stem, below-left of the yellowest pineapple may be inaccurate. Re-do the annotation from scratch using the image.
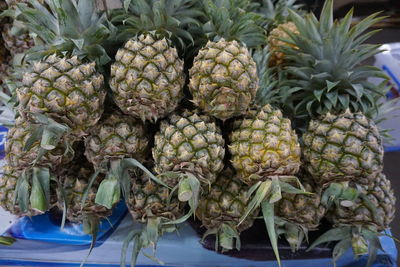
[196,169,259,232]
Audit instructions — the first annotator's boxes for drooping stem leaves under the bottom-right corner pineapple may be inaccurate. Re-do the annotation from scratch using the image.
[307,225,383,267]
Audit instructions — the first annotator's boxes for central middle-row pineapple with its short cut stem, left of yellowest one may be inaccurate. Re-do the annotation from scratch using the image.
[152,110,225,219]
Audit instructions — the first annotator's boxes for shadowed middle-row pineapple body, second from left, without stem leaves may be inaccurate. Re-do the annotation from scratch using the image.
[85,112,149,169]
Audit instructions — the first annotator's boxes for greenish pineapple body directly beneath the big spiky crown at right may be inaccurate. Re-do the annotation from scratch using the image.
[303,110,383,185]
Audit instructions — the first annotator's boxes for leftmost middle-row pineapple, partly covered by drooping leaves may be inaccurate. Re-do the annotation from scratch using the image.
[5,118,74,169]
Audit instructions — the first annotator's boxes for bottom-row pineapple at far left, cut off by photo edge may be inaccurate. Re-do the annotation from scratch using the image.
[0,165,57,216]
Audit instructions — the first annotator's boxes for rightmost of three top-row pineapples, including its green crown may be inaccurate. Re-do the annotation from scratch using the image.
[189,0,265,120]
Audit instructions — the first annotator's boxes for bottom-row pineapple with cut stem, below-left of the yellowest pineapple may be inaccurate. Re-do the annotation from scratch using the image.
[196,169,259,251]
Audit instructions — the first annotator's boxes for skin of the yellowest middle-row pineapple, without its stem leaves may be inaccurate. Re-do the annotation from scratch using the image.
[229,105,301,185]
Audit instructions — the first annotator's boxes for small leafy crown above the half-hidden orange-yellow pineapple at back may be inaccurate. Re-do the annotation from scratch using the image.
[250,0,302,32]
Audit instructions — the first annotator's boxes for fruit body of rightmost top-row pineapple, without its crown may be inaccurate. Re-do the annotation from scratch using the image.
[189,39,258,120]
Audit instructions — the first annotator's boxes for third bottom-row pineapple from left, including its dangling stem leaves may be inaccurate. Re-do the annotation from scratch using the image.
[125,175,184,266]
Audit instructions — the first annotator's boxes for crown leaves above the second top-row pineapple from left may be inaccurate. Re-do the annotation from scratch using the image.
[111,0,204,54]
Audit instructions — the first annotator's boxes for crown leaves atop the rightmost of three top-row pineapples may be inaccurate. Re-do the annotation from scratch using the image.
[202,0,266,48]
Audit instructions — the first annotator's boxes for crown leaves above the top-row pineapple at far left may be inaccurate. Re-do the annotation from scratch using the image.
[17,0,115,66]
